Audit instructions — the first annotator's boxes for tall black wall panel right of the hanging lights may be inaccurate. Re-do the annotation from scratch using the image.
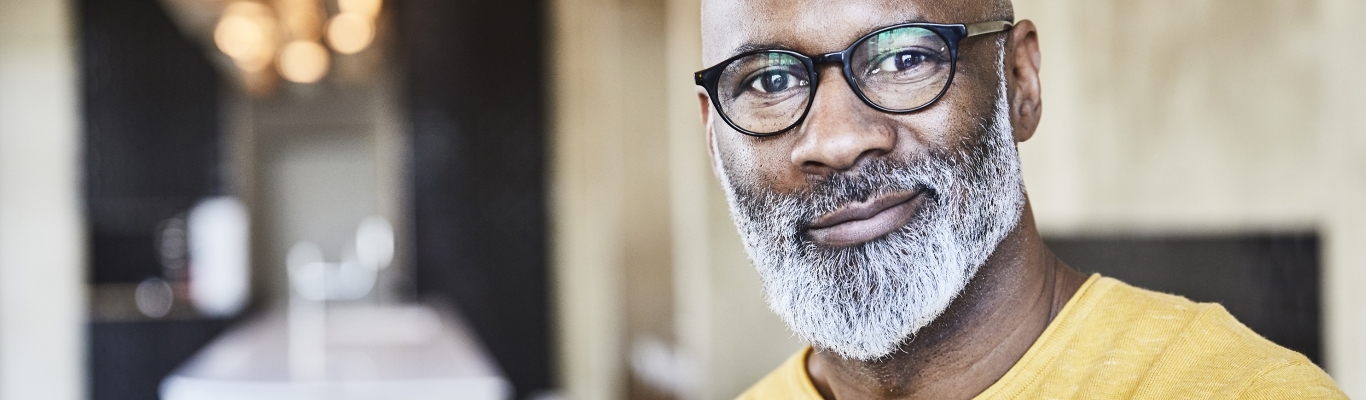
[393,0,550,396]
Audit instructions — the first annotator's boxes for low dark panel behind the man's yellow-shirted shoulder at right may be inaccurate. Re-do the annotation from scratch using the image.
[1046,233,1322,363]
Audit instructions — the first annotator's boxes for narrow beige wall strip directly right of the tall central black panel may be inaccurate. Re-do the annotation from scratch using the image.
[548,0,626,399]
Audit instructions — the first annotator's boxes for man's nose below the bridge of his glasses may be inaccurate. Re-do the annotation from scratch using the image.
[790,67,896,176]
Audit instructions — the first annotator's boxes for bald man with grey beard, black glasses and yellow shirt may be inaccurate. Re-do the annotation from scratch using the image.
[694,0,1344,399]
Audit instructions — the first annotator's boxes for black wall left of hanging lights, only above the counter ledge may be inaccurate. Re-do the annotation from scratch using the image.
[79,0,219,283]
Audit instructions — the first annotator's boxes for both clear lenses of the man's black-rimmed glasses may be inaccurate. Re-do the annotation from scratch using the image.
[716,27,953,134]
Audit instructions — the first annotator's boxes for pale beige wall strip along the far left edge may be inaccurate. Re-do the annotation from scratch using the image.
[0,0,85,400]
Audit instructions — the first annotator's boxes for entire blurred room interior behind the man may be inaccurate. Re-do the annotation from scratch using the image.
[0,0,1366,400]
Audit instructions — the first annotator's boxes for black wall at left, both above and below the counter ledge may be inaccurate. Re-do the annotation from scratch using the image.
[76,0,228,400]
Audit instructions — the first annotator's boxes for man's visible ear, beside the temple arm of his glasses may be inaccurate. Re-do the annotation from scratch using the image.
[1004,19,1044,142]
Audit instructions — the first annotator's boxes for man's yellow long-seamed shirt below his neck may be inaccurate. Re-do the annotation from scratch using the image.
[739,274,1347,400]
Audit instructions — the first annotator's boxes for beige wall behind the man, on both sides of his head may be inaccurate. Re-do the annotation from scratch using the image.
[550,0,1366,399]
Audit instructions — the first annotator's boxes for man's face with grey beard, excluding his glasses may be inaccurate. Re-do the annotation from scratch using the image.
[699,0,1025,359]
